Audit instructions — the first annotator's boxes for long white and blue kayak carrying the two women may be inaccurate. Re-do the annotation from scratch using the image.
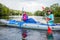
[0,20,60,30]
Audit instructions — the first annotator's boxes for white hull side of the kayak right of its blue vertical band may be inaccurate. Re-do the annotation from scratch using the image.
[22,23,60,30]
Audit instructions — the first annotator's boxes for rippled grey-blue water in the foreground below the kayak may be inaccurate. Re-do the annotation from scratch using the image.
[0,27,60,40]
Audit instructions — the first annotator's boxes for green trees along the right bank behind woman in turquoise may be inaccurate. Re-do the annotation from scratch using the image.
[34,3,60,17]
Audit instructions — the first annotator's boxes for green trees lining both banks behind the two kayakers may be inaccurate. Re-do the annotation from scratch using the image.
[0,3,60,23]
